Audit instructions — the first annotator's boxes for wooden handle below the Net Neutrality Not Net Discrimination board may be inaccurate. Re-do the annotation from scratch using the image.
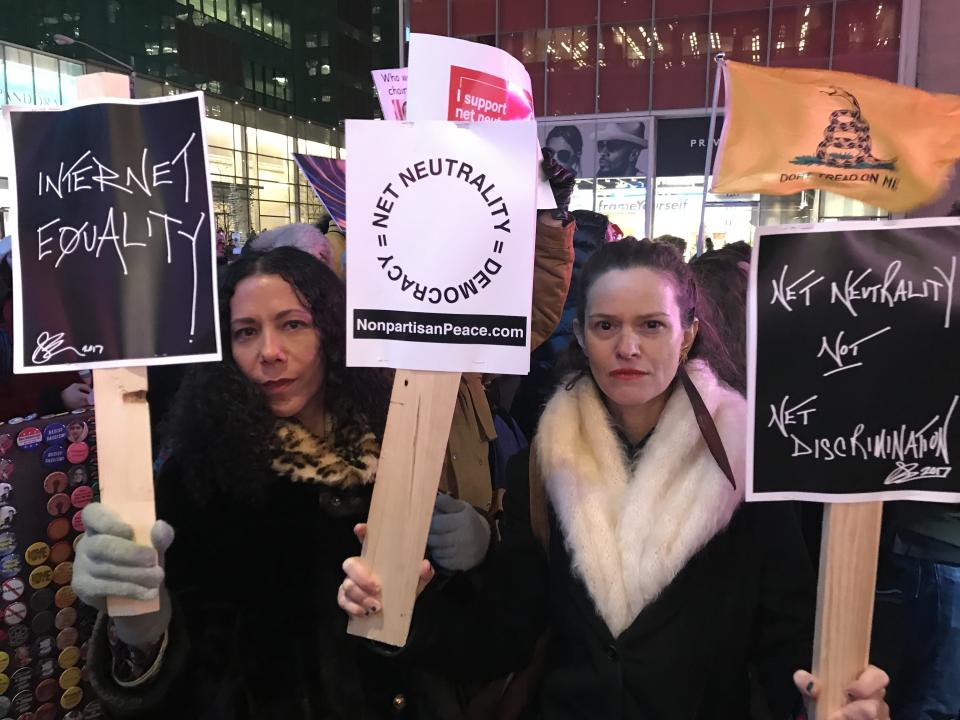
[811,502,883,720]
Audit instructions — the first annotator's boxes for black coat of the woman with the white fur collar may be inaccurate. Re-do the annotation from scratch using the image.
[424,444,816,720]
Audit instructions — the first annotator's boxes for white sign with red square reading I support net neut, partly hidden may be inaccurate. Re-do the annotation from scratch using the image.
[407,33,557,210]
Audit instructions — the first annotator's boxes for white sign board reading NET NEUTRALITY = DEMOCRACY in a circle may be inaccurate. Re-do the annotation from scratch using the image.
[347,120,536,374]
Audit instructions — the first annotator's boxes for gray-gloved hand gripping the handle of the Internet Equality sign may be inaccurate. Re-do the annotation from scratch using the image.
[73,503,173,648]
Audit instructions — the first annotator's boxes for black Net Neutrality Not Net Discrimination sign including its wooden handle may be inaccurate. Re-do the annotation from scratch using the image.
[747,219,960,718]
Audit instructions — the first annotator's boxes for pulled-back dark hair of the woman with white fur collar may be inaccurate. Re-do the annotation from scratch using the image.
[560,237,736,388]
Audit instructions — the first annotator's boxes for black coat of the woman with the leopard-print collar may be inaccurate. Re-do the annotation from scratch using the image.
[91,461,436,720]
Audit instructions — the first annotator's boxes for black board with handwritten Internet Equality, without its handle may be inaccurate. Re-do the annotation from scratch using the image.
[10,93,219,372]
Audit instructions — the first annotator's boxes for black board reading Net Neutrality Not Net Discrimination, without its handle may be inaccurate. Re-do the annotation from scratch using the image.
[748,220,960,502]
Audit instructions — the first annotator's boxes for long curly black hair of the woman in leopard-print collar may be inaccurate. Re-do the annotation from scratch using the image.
[165,247,389,499]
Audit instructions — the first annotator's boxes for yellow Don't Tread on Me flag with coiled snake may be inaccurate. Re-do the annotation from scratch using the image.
[713,62,960,212]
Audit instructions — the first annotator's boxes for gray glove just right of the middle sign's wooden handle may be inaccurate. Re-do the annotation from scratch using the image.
[427,493,490,570]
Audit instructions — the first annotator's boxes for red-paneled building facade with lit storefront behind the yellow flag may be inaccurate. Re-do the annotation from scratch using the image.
[407,0,919,245]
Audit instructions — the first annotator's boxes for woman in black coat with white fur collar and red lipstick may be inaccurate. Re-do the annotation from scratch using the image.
[341,239,889,720]
